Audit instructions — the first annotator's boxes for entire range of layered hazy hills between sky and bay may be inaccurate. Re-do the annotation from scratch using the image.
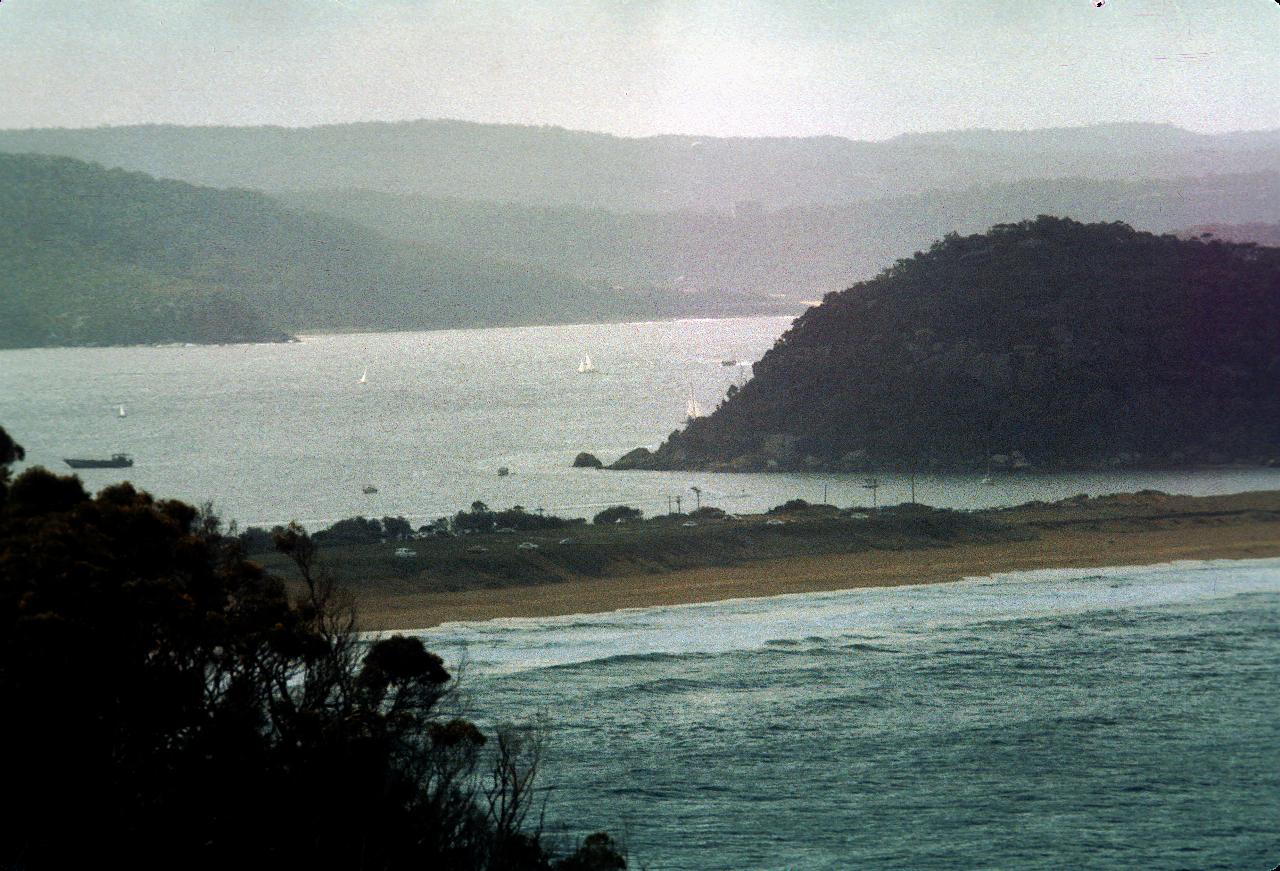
[0,120,1280,346]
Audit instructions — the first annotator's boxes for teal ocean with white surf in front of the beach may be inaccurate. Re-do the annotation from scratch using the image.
[422,560,1280,871]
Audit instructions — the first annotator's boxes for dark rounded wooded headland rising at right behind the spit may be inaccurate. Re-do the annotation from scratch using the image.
[616,216,1280,470]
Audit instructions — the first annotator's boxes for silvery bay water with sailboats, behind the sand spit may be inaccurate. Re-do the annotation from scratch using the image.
[0,318,1280,528]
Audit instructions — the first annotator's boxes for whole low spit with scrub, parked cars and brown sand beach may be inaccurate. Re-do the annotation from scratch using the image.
[240,492,1280,629]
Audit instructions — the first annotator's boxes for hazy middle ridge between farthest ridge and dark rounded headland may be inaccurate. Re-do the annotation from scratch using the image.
[279,171,1280,301]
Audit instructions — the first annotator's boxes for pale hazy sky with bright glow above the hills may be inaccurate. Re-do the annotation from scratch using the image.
[0,0,1280,138]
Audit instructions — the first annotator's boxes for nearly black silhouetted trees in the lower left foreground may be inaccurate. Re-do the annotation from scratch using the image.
[0,430,622,871]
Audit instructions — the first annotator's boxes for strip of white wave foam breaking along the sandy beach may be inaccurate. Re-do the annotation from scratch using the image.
[415,558,1280,674]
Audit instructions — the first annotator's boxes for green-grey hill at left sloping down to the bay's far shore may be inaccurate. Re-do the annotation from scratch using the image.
[0,155,776,347]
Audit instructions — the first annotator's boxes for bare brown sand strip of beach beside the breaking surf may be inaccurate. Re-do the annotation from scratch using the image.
[352,517,1280,631]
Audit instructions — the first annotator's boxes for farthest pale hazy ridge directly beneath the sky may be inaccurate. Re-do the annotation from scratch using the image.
[0,120,1280,214]
